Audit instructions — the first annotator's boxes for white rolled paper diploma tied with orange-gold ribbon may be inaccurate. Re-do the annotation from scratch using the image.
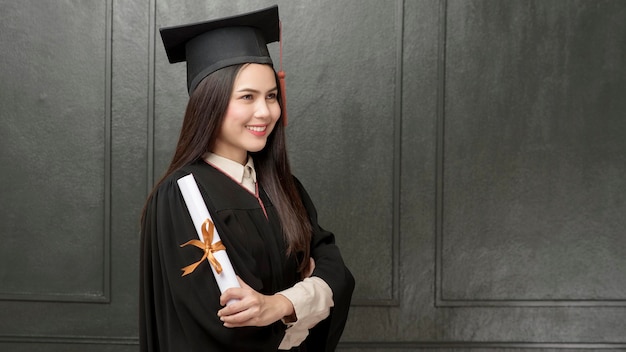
[177,174,240,294]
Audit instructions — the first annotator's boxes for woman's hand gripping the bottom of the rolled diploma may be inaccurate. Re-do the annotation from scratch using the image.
[217,277,294,328]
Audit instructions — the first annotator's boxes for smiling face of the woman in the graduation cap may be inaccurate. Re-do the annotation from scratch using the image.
[213,64,280,164]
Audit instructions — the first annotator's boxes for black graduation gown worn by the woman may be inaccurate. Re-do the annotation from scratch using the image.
[140,161,354,352]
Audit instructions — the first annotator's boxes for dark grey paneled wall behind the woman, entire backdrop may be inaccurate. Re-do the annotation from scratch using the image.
[0,0,626,352]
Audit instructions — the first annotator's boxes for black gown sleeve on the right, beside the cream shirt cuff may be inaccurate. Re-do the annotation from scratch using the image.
[296,179,355,351]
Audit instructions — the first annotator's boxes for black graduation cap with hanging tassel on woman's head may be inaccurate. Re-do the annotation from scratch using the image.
[159,5,287,123]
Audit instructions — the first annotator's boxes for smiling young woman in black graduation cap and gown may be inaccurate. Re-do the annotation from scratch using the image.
[140,7,354,352]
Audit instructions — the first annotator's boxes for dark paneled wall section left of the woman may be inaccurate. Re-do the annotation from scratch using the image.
[0,0,150,351]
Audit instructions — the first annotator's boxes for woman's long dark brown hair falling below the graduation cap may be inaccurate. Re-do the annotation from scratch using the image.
[142,64,313,273]
